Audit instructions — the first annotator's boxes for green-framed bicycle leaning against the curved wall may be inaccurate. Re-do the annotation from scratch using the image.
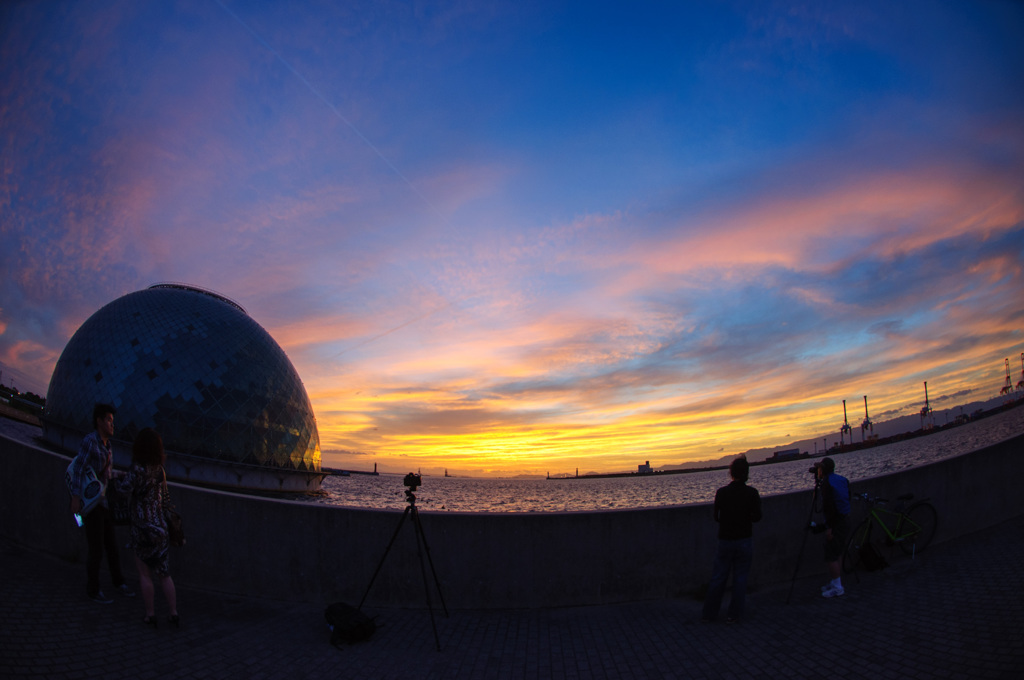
[843,494,939,573]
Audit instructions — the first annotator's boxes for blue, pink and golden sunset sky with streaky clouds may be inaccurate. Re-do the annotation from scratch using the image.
[0,0,1024,475]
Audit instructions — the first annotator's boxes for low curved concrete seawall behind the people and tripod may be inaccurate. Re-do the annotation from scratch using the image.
[0,428,1024,608]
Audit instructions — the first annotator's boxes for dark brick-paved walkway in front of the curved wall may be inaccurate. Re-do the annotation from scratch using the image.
[0,508,1024,680]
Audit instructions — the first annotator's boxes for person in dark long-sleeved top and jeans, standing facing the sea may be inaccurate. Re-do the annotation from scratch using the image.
[702,456,761,624]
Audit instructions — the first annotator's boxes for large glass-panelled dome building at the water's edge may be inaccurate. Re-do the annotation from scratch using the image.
[42,284,323,493]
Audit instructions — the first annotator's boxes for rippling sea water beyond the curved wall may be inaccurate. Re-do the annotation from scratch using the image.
[312,407,1024,512]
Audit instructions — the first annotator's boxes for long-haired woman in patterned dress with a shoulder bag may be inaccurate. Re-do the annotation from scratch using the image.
[117,427,179,628]
